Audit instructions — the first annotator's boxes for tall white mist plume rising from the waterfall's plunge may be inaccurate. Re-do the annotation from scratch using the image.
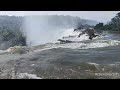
[23,16,77,46]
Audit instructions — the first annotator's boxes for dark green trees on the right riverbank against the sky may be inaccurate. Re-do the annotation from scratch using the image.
[94,12,120,31]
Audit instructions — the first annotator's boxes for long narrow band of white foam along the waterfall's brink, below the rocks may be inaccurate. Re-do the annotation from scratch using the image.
[33,40,120,52]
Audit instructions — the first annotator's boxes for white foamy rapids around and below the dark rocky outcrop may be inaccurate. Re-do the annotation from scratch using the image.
[31,29,120,50]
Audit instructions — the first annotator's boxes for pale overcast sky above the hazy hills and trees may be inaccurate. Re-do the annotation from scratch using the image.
[0,11,120,22]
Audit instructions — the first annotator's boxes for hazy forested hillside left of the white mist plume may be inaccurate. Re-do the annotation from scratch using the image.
[0,16,26,50]
